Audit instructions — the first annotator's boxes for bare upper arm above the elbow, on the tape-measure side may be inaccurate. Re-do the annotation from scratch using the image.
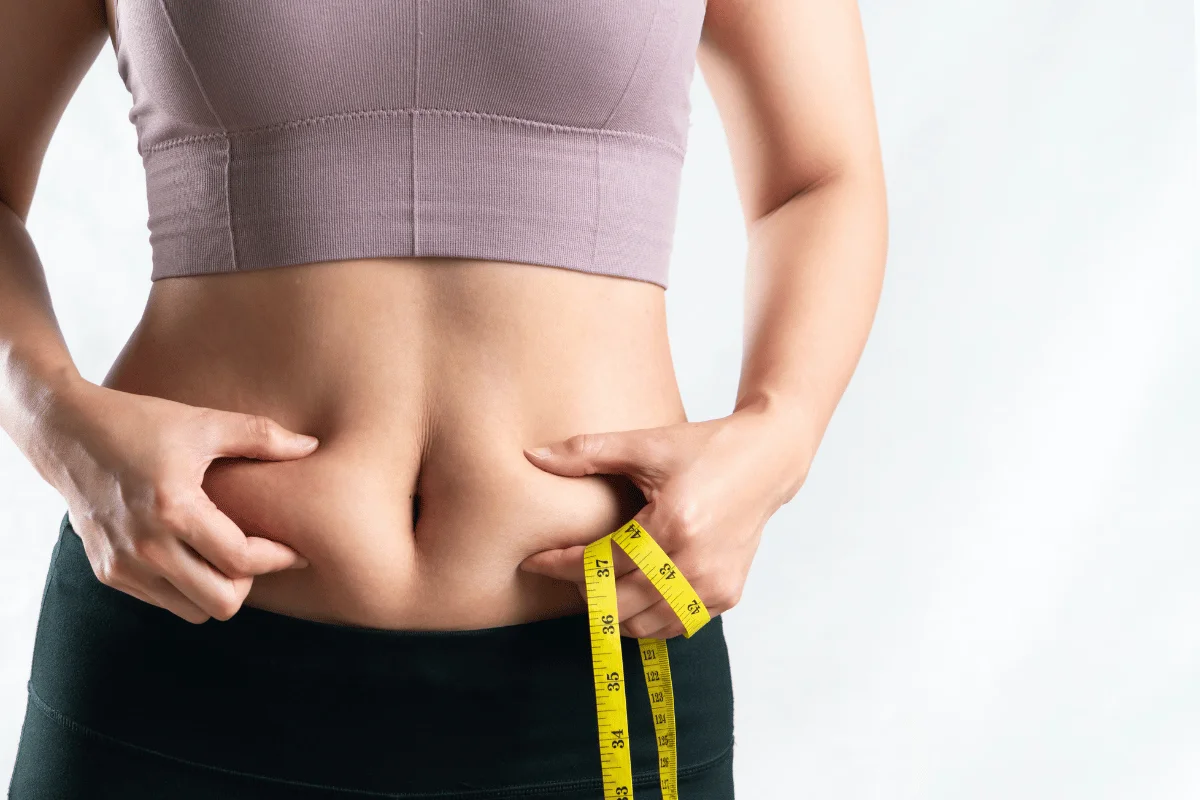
[696,0,882,223]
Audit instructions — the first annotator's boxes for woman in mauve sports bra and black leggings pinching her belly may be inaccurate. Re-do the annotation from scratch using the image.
[0,0,886,800]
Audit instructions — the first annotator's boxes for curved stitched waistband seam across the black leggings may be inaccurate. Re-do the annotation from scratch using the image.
[26,680,734,800]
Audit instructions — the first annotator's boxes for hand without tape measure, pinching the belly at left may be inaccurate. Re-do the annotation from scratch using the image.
[38,380,318,624]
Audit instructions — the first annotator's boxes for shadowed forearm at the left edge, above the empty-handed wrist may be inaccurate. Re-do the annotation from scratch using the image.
[0,203,82,482]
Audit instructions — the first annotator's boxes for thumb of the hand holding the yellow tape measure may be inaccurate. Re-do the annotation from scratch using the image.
[524,428,666,487]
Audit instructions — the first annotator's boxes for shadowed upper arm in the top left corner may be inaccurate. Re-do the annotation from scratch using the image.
[0,0,109,219]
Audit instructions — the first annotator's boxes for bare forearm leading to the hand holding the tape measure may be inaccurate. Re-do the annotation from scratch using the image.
[734,169,887,501]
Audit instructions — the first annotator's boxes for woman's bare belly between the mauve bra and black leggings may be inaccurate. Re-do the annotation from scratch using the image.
[104,259,685,630]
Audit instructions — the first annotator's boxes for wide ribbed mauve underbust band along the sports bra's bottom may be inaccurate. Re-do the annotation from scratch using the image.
[143,109,683,288]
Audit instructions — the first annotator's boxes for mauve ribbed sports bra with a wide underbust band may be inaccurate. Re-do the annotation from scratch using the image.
[115,0,706,289]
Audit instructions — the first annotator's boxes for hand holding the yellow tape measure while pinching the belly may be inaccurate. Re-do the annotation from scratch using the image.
[521,409,812,638]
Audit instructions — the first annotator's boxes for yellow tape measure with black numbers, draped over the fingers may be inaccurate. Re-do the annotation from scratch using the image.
[583,519,710,800]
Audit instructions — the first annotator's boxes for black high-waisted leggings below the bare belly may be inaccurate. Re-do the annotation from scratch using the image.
[10,516,733,800]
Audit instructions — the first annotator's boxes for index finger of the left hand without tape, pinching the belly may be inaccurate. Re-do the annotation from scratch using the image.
[178,492,308,578]
